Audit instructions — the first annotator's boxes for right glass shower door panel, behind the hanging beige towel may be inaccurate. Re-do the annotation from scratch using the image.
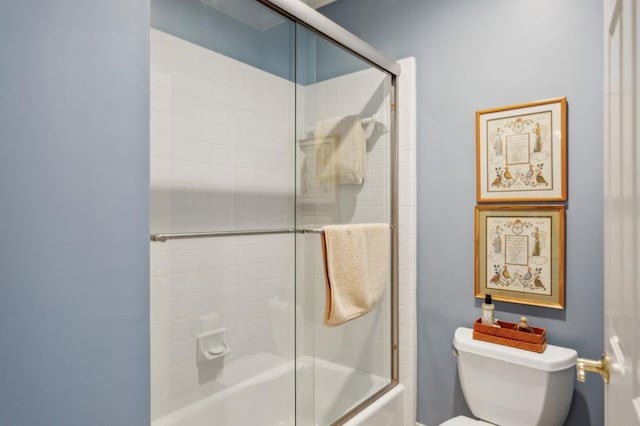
[295,25,392,425]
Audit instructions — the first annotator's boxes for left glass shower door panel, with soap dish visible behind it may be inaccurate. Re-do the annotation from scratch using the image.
[150,0,295,426]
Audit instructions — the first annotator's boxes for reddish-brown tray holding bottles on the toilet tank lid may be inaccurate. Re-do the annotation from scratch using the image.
[473,318,547,353]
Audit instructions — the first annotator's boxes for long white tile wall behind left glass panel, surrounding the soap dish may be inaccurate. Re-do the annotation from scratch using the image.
[150,30,294,419]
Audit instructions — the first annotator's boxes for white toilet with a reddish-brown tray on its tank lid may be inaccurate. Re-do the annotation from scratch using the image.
[441,327,578,426]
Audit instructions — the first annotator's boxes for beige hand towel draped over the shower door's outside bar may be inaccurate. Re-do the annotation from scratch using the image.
[322,223,391,326]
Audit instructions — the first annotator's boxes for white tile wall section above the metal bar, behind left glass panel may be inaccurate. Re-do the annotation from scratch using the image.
[151,30,295,236]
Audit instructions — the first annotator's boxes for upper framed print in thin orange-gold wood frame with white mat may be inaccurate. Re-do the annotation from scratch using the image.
[476,98,567,202]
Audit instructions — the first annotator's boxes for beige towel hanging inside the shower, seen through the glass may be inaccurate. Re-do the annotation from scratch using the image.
[314,115,367,184]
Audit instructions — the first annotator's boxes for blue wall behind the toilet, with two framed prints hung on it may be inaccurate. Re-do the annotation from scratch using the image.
[322,0,603,426]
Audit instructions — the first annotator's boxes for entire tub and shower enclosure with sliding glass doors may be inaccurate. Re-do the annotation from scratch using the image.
[150,0,404,426]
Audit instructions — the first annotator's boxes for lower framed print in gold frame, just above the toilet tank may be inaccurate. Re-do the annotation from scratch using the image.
[475,205,565,309]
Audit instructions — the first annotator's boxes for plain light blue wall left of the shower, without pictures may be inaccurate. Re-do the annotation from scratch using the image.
[0,0,149,426]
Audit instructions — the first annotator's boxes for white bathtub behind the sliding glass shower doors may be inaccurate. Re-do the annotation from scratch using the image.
[152,357,404,426]
